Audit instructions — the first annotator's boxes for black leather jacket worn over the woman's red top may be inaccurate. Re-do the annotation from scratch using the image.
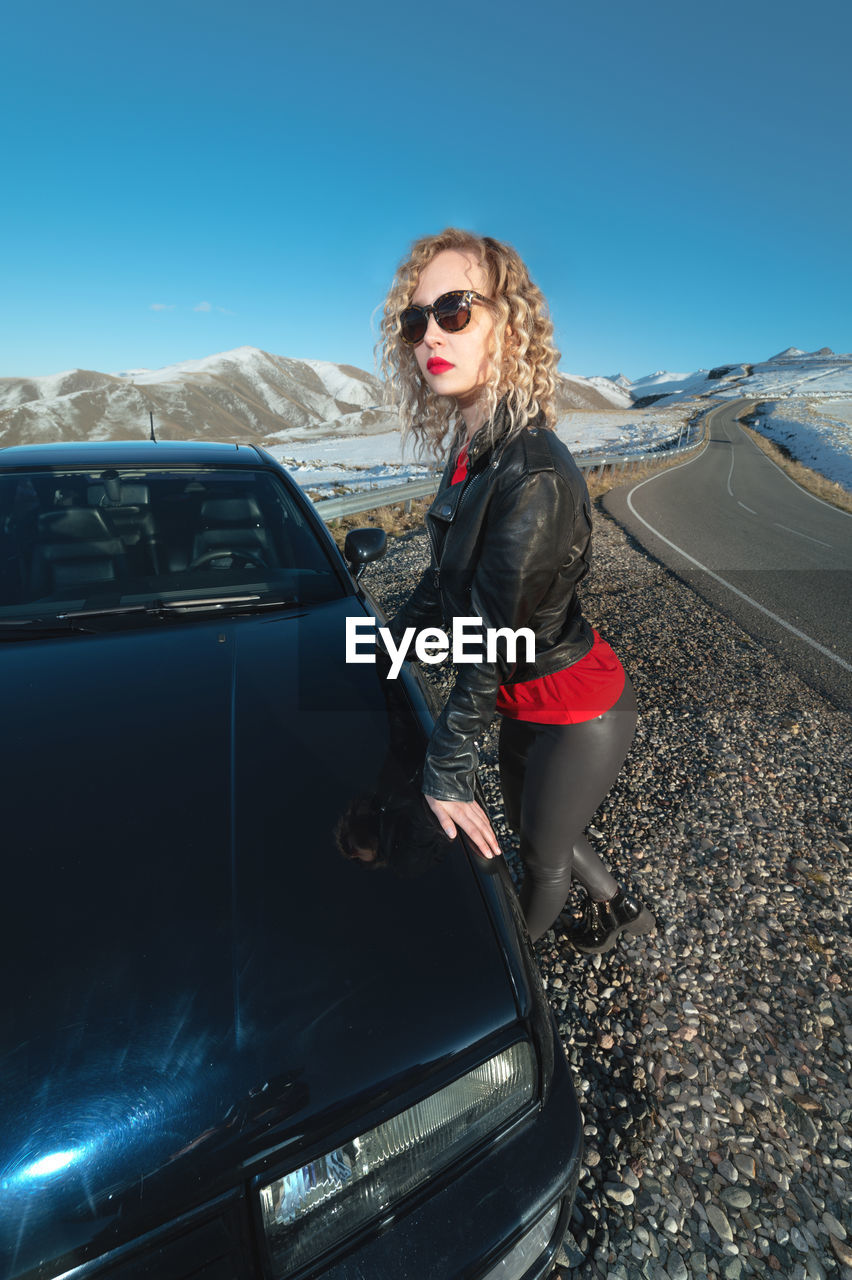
[389,403,592,800]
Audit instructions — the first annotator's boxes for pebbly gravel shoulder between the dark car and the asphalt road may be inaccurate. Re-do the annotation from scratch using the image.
[365,499,852,1280]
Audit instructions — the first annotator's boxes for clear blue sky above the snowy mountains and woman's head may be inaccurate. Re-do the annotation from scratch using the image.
[0,0,852,378]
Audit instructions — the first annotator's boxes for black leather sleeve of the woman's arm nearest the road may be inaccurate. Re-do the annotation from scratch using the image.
[422,471,574,800]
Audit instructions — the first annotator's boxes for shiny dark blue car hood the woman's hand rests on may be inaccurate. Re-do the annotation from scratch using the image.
[0,598,518,1272]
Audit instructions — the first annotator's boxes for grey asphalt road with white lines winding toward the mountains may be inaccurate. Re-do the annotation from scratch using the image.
[604,401,852,709]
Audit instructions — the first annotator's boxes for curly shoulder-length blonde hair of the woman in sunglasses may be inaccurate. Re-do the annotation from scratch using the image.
[376,227,559,460]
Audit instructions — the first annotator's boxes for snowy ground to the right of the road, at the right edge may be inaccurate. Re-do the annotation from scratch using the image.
[760,397,852,489]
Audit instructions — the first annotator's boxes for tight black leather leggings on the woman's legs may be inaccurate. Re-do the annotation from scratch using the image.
[499,677,637,942]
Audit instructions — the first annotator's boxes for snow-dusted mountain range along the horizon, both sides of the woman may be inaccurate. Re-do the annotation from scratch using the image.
[0,347,852,448]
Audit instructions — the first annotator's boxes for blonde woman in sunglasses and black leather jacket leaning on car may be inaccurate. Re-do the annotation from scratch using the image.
[381,228,655,954]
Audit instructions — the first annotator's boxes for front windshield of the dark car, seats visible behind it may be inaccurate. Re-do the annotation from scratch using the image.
[0,467,344,622]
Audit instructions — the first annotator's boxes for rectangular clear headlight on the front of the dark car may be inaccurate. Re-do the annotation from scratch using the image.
[260,1041,536,1276]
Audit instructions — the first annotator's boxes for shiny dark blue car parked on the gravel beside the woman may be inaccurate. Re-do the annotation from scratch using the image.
[0,442,581,1280]
